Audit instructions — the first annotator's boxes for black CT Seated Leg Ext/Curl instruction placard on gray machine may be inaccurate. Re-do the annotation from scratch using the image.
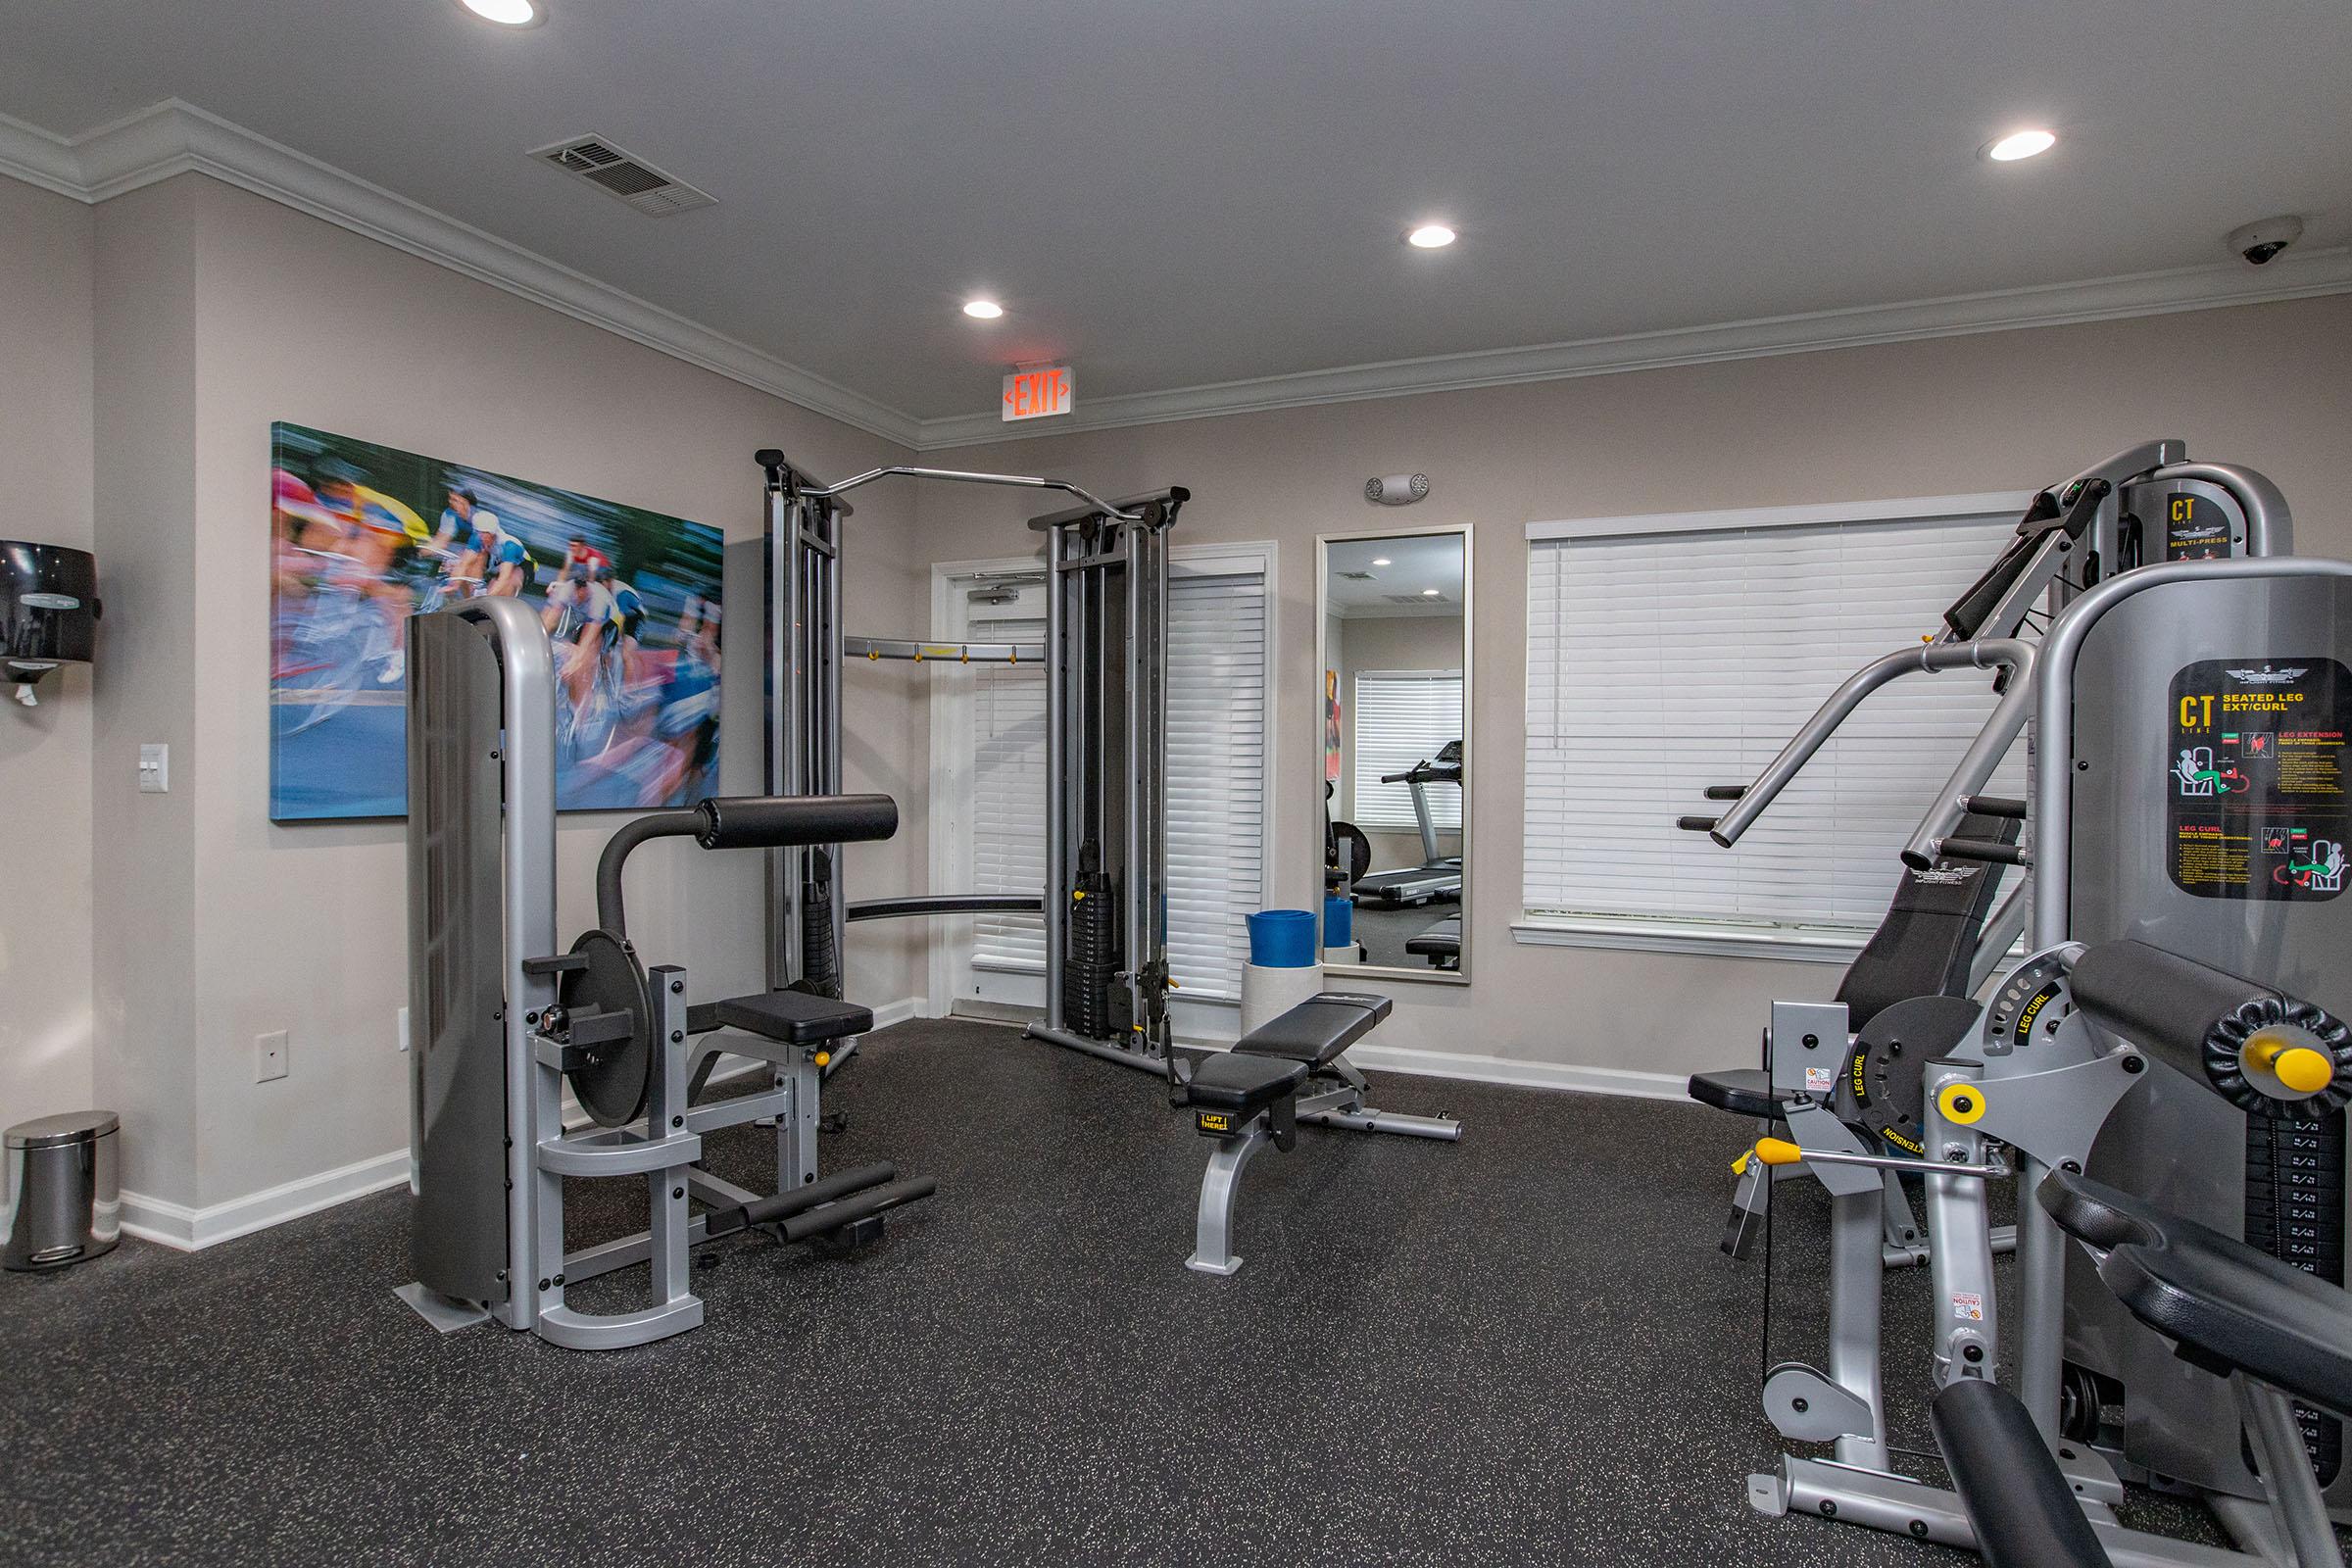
[2166,659,2352,903]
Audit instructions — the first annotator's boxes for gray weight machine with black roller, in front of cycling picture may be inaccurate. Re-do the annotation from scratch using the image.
[400,600,934,1349]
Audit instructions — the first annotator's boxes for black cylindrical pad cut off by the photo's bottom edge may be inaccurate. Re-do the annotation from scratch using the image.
[1927,1378,2107,1568]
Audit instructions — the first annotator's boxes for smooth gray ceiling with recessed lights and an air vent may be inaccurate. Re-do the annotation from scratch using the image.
[0,0,2352,416]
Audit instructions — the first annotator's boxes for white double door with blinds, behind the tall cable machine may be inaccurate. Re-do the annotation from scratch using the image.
[931,550,1270,1039]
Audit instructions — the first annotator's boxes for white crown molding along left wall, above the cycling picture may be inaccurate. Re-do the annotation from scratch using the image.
[0,99,919,447]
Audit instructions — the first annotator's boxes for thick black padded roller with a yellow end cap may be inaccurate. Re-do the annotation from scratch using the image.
[2068,943,2352,1119]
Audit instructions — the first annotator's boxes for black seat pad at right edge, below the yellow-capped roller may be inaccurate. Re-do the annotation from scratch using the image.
[2034,1171,2352,1415]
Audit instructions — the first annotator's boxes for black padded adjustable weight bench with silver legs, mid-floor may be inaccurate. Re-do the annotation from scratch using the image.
[1183,992,1463,1274]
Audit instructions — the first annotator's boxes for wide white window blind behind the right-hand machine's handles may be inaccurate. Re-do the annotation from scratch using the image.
[1524,499,2025,929]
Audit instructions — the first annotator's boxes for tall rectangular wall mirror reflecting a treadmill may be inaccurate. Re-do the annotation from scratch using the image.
[1315,529,1470,985]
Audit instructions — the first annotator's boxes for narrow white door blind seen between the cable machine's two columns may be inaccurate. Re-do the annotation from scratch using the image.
[964,613,1045,971]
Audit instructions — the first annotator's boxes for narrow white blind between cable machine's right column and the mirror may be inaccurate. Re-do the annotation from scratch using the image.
[1166,564,1265,1002]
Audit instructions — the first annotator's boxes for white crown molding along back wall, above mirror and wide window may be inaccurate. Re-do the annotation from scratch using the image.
[915,247,2352,452]
